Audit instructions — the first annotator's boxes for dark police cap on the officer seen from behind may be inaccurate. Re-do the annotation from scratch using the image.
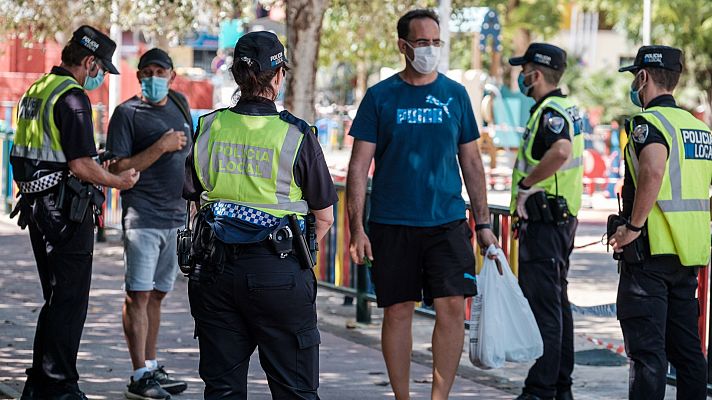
[235,31,288,71]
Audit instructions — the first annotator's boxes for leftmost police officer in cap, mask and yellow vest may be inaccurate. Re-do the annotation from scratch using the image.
[11,26,138,400]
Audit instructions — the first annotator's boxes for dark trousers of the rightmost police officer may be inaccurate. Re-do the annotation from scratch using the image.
[616,256,707,400]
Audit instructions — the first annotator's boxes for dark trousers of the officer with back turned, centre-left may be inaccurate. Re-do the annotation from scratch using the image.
[188,242,321,400]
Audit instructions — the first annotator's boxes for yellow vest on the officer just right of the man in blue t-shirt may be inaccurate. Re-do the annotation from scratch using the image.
[510,96,584,216]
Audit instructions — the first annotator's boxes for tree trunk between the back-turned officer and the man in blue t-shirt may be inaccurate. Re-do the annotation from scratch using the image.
[284,0,329,123]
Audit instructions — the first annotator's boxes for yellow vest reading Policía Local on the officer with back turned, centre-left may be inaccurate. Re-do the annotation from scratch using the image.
[193,109,309,218]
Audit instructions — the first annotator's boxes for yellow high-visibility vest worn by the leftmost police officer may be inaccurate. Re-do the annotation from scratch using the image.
[12,74,82,163]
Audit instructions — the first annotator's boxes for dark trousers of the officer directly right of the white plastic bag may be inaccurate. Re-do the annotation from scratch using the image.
[519,217,578,399]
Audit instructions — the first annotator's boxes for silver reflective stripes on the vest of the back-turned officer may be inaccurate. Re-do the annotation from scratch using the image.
[195,111,309,215]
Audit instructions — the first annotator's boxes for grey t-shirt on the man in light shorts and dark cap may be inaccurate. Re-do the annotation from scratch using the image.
[106,95,193,229]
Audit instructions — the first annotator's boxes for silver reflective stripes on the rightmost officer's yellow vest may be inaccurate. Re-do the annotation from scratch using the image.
[627,110,710,212]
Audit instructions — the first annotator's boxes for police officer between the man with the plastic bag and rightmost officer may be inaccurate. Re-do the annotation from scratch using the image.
[509,43,584,400]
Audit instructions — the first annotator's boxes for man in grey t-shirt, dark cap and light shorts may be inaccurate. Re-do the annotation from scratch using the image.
[106,49,192,399]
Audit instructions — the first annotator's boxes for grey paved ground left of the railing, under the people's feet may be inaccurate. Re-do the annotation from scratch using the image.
[0,221,512,400]
